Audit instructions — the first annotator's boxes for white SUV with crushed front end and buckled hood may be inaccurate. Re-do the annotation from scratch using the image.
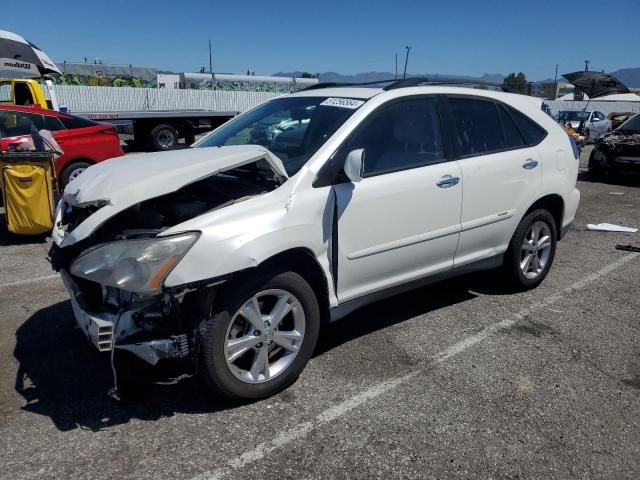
[50,79,580,400]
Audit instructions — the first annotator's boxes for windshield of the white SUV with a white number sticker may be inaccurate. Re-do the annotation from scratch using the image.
[195,97,364,176]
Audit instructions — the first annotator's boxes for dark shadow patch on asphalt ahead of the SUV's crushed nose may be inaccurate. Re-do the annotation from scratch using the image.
[14,301,228,431]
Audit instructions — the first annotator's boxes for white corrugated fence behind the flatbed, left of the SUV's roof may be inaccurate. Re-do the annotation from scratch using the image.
[53,85,282,113]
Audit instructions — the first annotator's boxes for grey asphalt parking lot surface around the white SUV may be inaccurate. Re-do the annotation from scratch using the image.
[0,147,640,480]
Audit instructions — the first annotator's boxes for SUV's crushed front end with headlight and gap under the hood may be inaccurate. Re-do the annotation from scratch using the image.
[49,158,280,398]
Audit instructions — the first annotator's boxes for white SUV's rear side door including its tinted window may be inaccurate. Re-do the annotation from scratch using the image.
[449,96,546,266]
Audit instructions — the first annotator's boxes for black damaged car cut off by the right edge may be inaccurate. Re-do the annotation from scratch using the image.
[589,114,640,177]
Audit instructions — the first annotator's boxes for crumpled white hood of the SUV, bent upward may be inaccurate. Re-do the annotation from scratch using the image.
[53,145,287,247]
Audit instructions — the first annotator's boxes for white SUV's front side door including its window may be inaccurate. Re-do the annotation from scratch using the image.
[334,97,462,302]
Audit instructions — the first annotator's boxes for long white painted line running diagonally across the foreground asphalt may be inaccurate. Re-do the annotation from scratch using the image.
[192,253,640,480]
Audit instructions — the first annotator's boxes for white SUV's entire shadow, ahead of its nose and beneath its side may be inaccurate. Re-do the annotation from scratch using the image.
[14,273,510,431]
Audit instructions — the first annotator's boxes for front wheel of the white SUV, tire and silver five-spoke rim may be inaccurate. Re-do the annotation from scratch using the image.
[198,272,320,402]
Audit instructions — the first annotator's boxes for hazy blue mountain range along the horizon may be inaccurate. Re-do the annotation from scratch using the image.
[273,67,640,88]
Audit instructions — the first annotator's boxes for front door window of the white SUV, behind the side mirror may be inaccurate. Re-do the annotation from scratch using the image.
[345,98,444,177]
